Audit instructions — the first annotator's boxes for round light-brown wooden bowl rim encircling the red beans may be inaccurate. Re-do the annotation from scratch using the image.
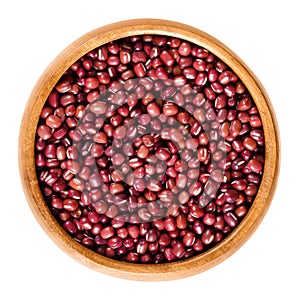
[19,19,279,281]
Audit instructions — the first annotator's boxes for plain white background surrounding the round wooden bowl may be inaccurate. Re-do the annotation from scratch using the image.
[0,0,300,300]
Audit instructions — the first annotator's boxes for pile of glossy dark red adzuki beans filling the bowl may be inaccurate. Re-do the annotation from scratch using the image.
[35,35,265,263]
